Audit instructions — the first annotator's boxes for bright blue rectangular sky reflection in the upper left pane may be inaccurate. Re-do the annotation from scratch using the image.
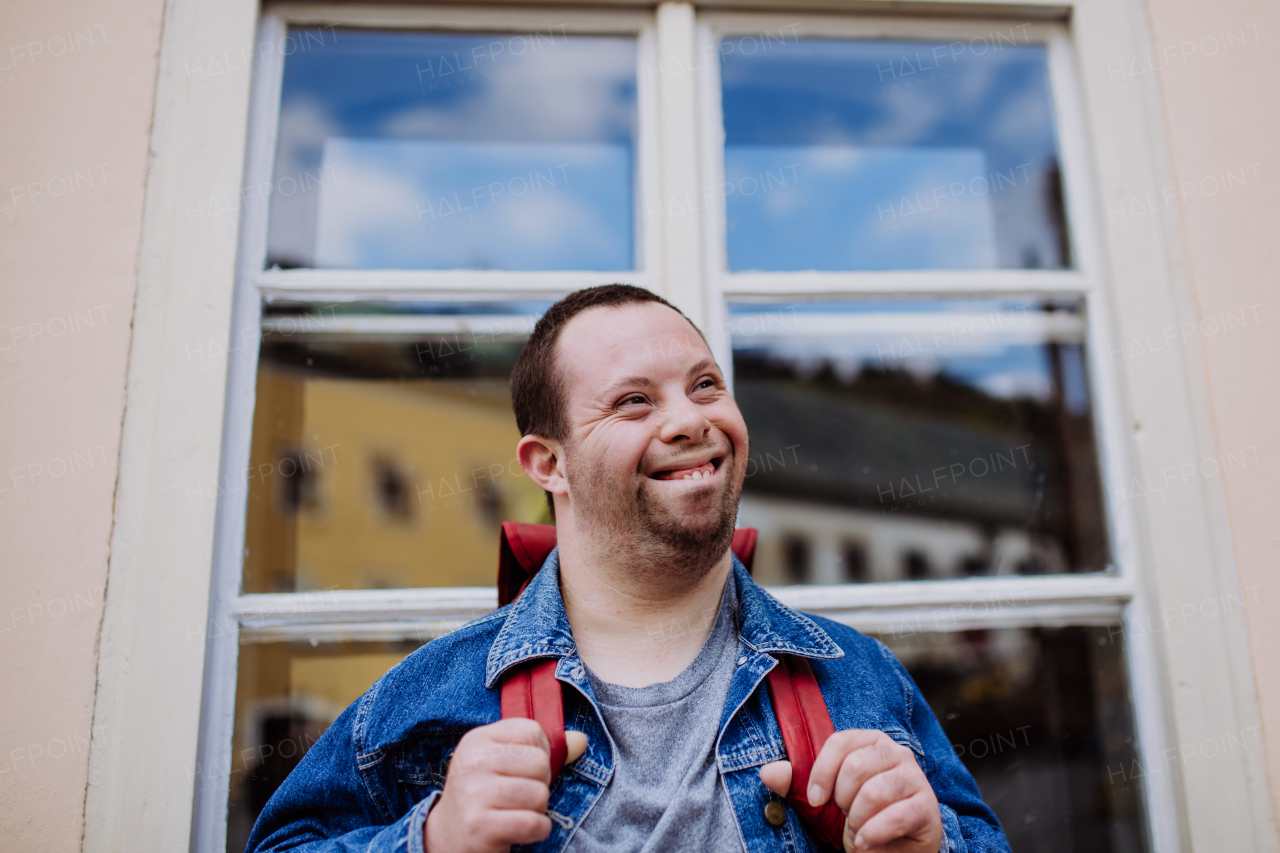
[315,138,631,270]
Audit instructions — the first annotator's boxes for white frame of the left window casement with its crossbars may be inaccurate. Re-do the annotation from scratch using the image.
[192,4,663,853]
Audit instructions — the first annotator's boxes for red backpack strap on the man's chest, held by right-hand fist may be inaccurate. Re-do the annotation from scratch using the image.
[768,654,845,849]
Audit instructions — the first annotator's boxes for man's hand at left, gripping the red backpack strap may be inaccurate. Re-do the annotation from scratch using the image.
[425,717,586,853]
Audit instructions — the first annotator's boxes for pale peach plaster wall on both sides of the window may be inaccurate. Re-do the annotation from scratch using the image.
[0,0,1280,850]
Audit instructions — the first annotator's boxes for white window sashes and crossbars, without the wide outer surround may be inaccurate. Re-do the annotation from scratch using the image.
[197,4,1172,853]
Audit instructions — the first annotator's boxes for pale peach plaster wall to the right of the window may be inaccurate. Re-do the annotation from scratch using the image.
[1146,0,1280,815]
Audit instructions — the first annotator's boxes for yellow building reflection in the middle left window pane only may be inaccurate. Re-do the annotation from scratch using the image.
[244,365,549,593]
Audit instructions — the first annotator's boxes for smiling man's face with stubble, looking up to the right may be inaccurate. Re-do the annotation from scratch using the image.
[557,302,748,569]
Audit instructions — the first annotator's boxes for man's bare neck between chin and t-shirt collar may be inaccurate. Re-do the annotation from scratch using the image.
[559,537,733,688]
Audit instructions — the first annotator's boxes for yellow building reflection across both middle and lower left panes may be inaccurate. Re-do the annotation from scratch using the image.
[227,362,550,850]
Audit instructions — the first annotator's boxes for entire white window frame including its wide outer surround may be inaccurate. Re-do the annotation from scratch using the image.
[84,0,1275,853]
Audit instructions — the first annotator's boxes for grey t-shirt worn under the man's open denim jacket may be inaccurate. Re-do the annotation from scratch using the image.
[568,574,744,853]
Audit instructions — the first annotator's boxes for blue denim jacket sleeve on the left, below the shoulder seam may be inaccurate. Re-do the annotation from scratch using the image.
[244,694,439,853]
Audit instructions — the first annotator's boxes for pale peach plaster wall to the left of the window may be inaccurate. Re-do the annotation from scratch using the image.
[0,0,163,850]
